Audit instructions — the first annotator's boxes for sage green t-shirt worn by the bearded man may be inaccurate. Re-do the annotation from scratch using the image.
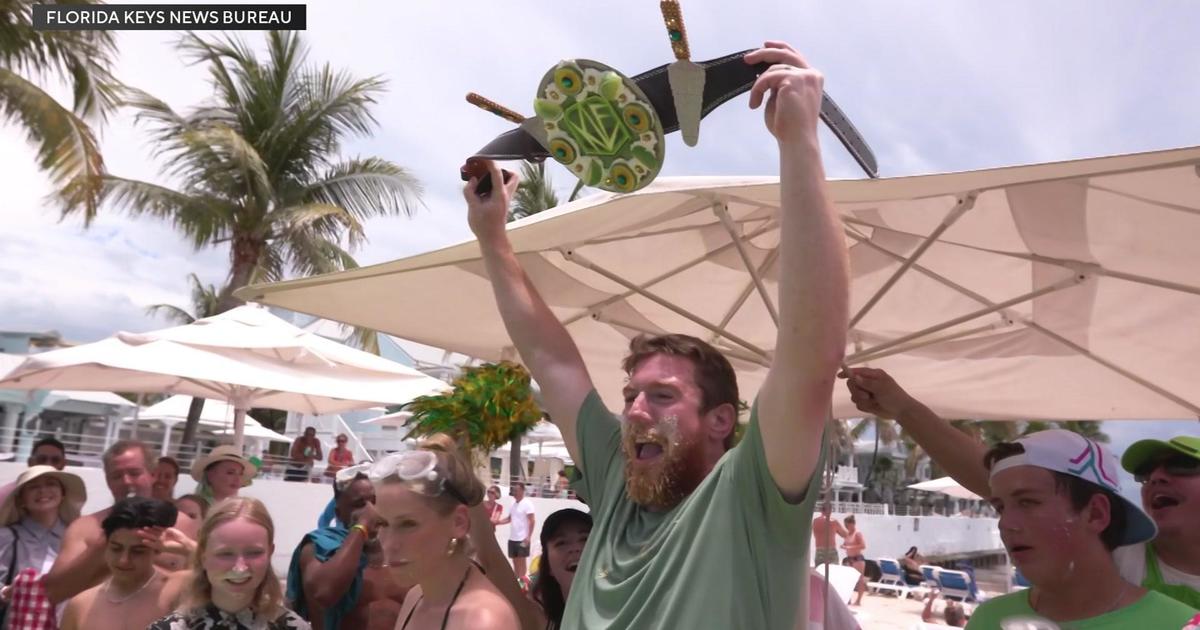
[563,391,821,630]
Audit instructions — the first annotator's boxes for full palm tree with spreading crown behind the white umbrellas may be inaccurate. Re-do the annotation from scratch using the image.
[104,31,421,443]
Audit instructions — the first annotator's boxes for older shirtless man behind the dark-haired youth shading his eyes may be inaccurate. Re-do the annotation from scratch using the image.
[44,440,197,602]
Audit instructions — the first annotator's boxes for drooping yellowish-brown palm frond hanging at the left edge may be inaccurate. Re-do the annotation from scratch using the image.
[0,67,104,224]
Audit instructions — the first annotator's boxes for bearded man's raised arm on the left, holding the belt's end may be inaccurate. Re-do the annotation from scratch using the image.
[463,161,593,462]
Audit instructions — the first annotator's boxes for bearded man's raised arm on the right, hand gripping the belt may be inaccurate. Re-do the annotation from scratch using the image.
[745,42,850,500]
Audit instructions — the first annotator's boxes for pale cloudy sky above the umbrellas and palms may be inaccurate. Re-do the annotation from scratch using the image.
[0,0,1200,450]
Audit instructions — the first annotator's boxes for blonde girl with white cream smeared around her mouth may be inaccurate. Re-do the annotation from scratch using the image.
[146,497,310,630]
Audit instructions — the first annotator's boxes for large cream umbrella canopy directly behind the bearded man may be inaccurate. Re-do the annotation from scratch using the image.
[240,148,1200,420]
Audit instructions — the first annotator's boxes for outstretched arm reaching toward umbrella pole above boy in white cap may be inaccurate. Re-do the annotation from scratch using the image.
[839,367,991,497]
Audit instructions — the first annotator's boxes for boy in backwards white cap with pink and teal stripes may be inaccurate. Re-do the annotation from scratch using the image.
[967,430,1196,630]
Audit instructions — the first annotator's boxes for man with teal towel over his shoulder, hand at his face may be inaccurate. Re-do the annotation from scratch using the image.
[288,467,408,630]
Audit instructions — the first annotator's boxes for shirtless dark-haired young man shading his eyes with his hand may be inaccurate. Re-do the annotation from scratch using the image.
[61,497,190,630]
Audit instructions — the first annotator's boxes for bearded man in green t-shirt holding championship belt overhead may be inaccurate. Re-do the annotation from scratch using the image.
[464,42,848,630]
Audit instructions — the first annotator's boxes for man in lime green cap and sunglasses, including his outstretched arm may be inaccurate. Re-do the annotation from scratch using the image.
[839,367,1200,608]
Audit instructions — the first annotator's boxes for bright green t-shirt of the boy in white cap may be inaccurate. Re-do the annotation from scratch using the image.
[967,589,1196,630]
